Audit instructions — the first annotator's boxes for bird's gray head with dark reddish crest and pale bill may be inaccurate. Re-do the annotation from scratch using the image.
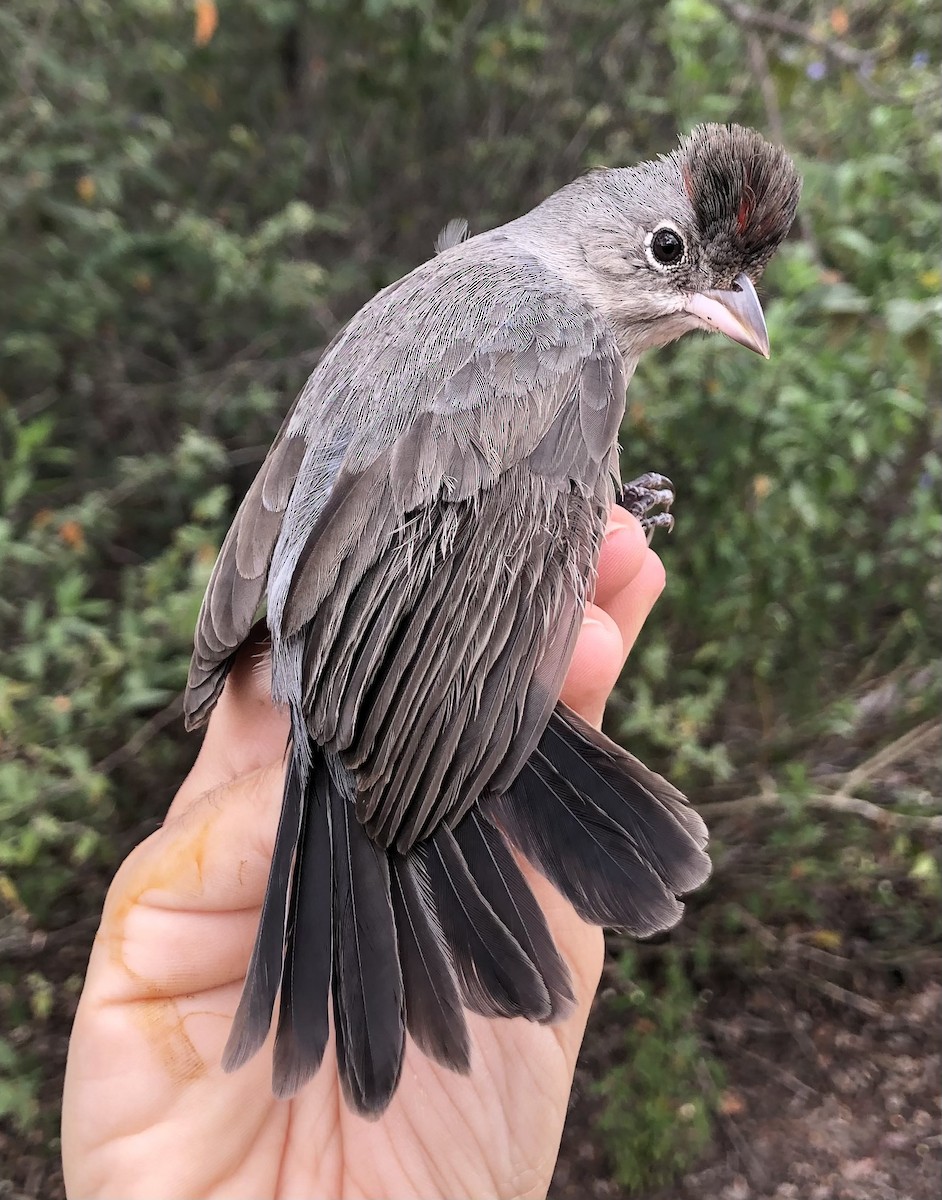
[518,125,802,358]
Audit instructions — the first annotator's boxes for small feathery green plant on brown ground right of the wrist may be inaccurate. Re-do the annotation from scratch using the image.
[599,952,724,1195]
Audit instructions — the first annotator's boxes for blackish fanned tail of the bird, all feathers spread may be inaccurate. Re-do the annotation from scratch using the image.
[223,704,709,1116]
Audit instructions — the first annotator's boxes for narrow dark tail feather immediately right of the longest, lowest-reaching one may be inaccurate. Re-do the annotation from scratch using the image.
[390,854,470,1074]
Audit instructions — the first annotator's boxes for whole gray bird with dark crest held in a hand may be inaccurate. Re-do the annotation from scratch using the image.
[186,125,800,1115]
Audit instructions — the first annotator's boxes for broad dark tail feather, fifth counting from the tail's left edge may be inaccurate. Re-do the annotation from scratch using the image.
[422,826,551,1021]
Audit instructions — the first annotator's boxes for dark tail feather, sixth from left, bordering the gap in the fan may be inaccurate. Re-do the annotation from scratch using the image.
[455,810,576,1021]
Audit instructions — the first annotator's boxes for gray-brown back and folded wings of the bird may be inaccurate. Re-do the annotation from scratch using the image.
[187,242,625,851]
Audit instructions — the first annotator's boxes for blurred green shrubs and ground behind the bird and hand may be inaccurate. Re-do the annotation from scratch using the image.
[0,0,942,1200]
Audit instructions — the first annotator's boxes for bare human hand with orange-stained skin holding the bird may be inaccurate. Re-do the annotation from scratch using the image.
[62,509,664,1200]
